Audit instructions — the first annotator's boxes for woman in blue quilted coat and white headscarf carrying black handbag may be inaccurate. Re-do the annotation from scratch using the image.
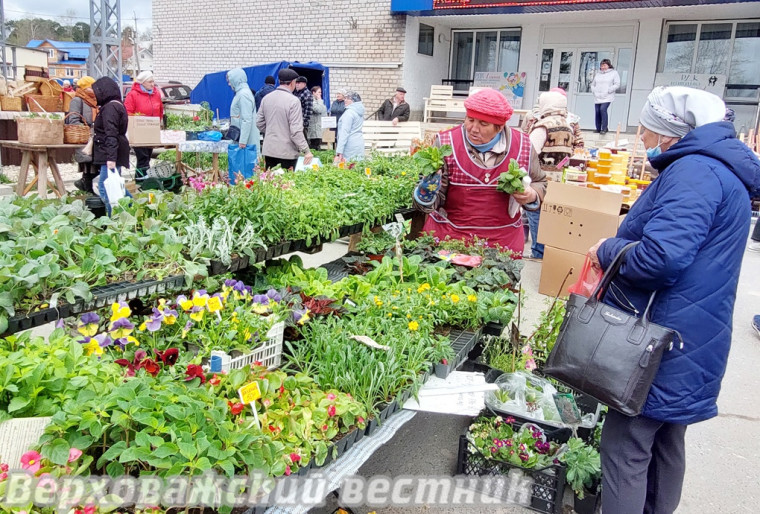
[589,87,760,514]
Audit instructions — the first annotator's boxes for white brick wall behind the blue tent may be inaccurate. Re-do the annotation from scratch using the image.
[153,0,406,114]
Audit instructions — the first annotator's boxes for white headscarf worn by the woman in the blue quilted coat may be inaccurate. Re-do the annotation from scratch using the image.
[639,86,726,138]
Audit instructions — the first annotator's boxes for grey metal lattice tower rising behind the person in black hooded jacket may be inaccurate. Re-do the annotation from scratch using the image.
[89,0,122,88]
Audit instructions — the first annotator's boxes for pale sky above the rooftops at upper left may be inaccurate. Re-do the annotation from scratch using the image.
[2,0,152,31]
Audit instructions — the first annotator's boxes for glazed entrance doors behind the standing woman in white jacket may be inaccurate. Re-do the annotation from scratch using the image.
[538,46,633,131]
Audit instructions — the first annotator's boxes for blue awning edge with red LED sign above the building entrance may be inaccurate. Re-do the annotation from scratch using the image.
[391,0,760,16]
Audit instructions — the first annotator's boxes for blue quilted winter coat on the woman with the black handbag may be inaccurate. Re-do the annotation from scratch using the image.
[597,122,760,425]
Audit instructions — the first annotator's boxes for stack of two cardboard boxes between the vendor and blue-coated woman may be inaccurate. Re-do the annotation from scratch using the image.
[538,182,623,297]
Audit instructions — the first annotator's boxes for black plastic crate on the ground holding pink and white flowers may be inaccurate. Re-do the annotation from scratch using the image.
[457,431,565,514]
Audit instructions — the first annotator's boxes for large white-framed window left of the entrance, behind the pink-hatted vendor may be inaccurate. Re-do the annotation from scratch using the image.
[449,28,522,91]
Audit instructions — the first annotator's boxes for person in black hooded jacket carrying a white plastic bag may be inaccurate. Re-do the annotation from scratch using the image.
[92,77,131,216]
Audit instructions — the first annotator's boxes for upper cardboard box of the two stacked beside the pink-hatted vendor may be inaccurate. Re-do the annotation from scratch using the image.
[537,182,623,255]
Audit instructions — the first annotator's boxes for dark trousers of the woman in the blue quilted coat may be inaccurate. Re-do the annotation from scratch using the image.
[601,409,686,514]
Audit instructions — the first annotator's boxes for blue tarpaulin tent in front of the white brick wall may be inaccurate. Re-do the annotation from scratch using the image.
[190,61,330,119]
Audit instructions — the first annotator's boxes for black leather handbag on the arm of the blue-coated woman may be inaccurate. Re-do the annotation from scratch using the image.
[544,243,683,416]
